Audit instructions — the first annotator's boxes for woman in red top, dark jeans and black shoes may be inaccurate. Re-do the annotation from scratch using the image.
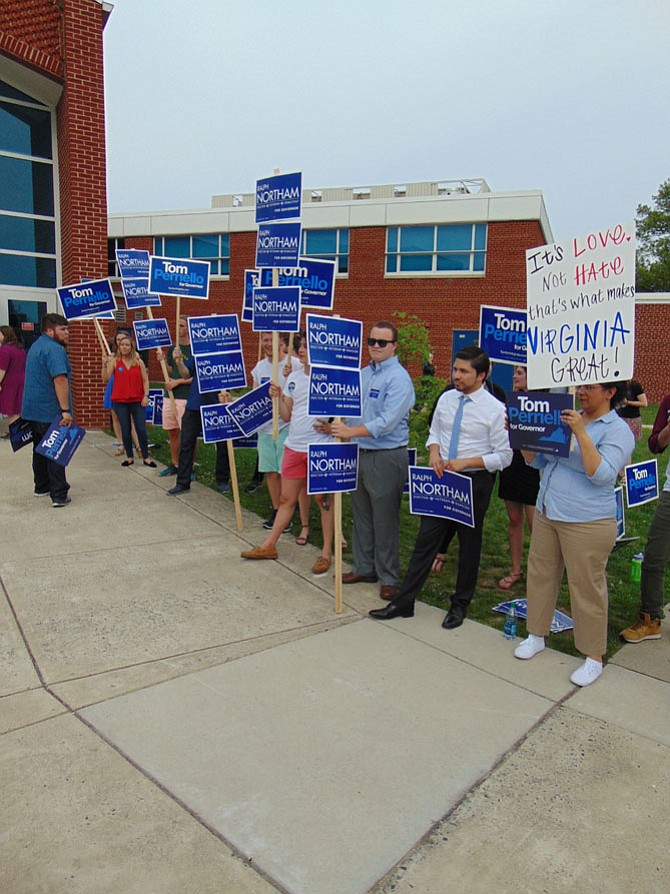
[106,334,156,469]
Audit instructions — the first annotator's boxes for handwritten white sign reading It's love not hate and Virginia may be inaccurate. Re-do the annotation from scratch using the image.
[526,223,635,389]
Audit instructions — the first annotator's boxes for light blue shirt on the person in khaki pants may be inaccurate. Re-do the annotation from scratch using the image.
[530,410,635,522]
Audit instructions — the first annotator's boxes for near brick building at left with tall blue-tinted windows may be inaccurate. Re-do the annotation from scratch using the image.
[0,0,112,427]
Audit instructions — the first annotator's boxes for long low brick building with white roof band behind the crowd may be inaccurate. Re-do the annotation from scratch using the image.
[109,179,552,396]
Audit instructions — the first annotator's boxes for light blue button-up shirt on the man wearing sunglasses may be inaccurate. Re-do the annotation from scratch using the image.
[347,355,415,450]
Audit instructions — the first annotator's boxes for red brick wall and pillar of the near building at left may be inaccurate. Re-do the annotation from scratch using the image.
[0,0,107,428]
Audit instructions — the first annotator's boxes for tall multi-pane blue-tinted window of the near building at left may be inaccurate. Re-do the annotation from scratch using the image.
[0,80,56,289]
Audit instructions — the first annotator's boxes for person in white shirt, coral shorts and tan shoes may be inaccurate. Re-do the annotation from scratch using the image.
[241,332,334,575]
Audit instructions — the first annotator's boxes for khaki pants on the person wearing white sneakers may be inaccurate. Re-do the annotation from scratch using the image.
[526,510,616,656]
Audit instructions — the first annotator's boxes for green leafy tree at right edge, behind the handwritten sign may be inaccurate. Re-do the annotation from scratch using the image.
[636,180,670,292]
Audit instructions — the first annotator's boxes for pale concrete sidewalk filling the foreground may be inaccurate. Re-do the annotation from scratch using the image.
[0,432,670,894]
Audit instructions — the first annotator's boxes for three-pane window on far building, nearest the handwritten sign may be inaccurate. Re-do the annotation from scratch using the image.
[386,224,487,275]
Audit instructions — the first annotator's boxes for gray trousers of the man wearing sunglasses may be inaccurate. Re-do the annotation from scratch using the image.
[351,447,409,586]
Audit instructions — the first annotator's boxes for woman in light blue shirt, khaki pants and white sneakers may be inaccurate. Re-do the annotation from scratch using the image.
[514,382,634,686]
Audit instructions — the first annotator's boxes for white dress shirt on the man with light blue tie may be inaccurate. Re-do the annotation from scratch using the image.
[426,387,512,472]
